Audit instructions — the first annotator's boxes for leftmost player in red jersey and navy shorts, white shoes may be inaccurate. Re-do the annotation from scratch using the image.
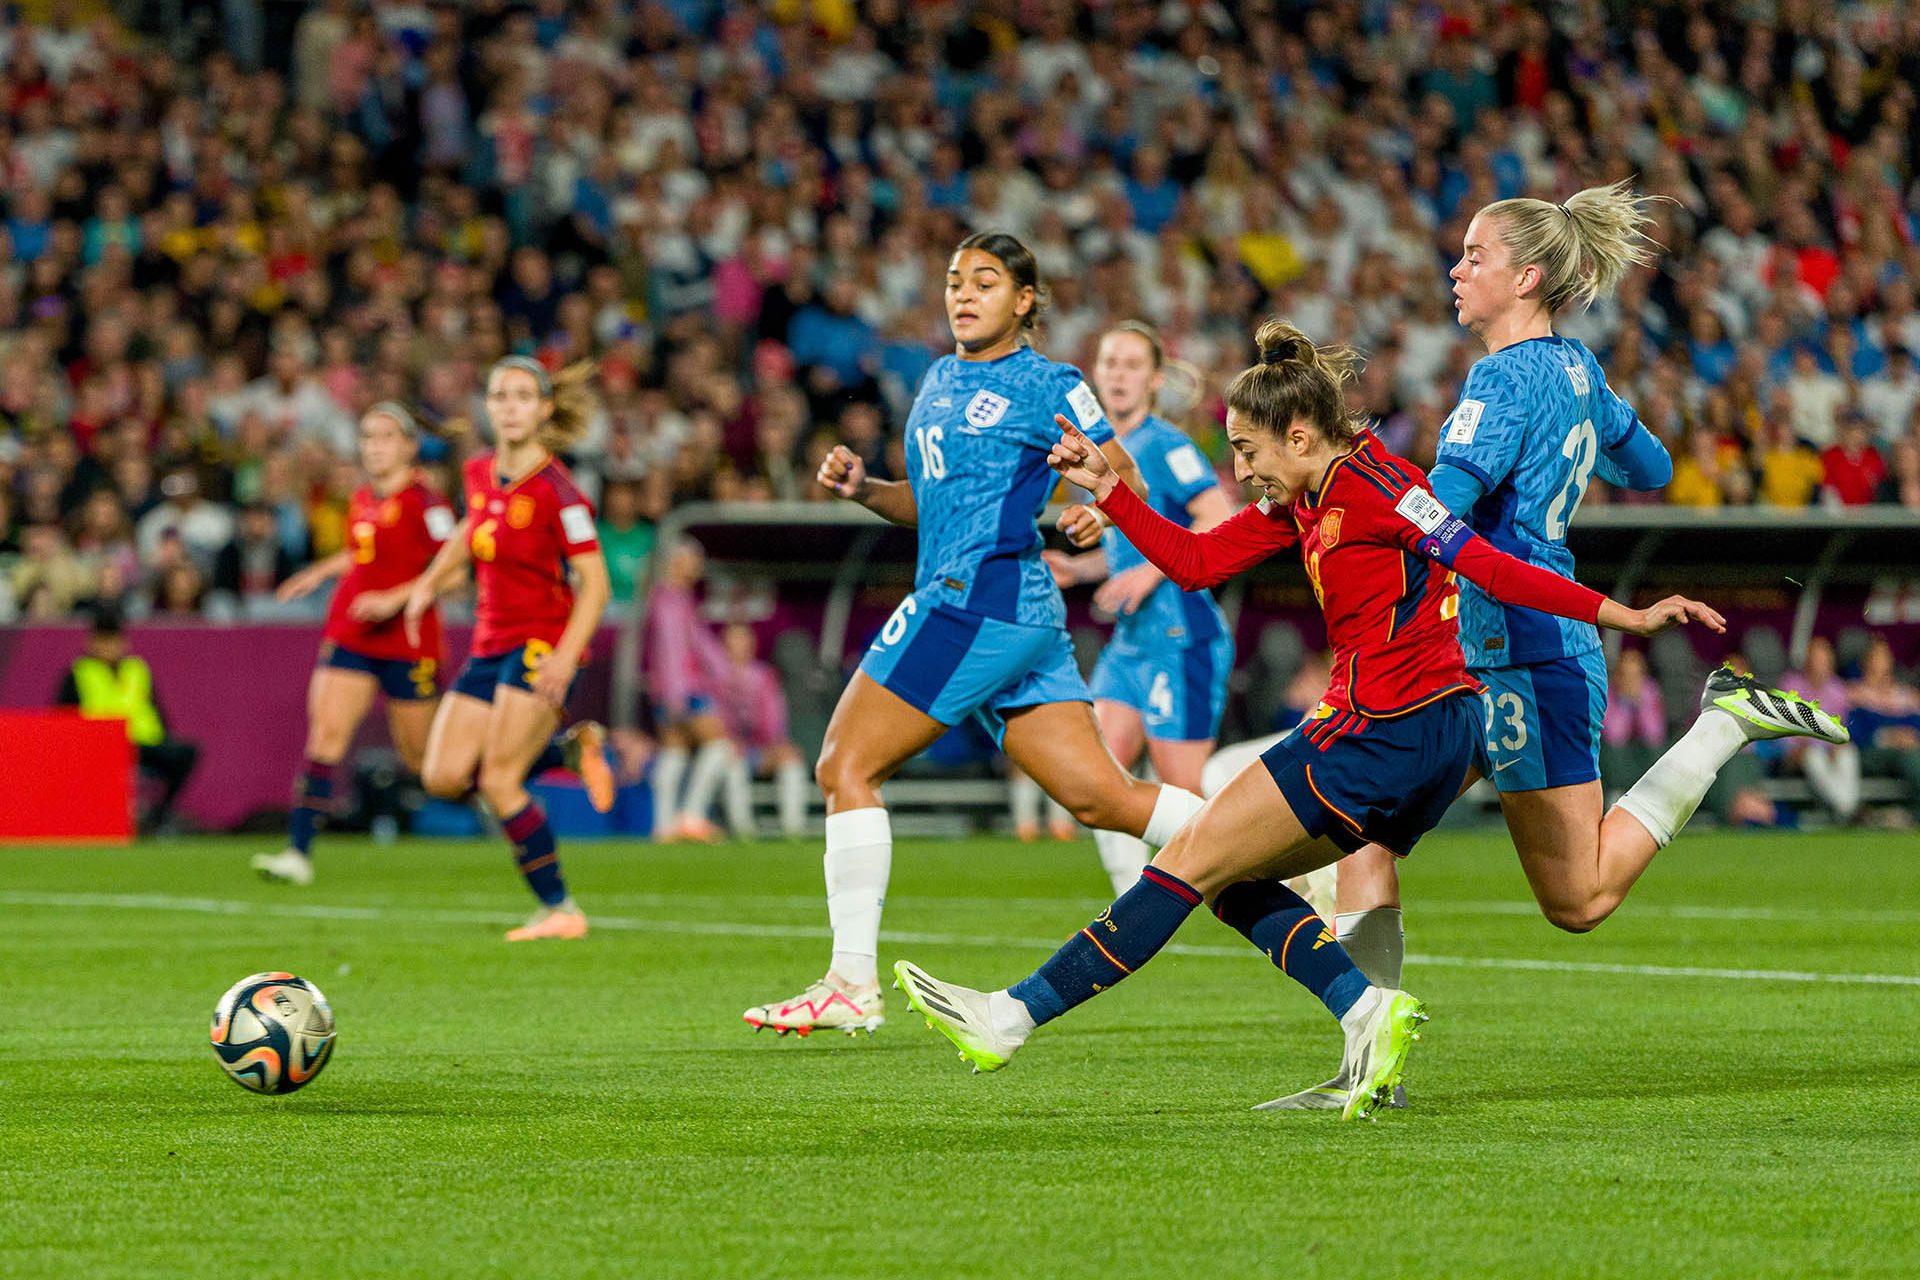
[253,401,453,885]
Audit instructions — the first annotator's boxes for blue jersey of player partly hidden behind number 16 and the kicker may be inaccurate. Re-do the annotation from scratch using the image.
[1100,416,1227,649]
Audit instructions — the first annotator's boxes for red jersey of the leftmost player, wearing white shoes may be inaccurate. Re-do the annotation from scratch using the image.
[326,476,453,662]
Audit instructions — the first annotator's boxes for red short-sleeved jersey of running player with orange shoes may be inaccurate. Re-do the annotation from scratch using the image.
[467,453,599,656]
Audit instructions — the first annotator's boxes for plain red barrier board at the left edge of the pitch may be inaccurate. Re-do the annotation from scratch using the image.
[0,710,134,844]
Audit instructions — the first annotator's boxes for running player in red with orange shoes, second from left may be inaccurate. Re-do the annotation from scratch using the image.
[405,355,612,942]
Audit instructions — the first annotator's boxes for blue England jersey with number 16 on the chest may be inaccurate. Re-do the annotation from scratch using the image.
[906,347,1114,628]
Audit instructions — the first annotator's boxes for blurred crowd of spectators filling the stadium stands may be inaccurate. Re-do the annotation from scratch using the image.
[0,0,1920,637]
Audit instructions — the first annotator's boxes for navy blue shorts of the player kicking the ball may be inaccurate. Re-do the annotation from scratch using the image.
[1260,693,1480,858]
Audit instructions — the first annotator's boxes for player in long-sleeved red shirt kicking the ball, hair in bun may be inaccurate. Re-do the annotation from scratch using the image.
[895,320,1724,1117]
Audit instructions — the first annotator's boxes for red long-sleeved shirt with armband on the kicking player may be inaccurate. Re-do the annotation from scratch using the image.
[1100,432,1605,718]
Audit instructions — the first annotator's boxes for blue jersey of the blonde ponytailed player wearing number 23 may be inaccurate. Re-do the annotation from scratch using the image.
[1434,336,1640,668]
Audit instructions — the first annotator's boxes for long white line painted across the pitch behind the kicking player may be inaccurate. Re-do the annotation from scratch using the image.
[11,890,1920,986]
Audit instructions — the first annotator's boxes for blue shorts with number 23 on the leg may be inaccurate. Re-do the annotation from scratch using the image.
[1473,649,1607,791]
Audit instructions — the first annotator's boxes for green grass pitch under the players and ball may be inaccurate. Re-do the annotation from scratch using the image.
[0,833,1920,1278]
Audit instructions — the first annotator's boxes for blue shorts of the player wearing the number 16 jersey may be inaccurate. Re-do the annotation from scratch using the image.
[860,595,1092,747]
